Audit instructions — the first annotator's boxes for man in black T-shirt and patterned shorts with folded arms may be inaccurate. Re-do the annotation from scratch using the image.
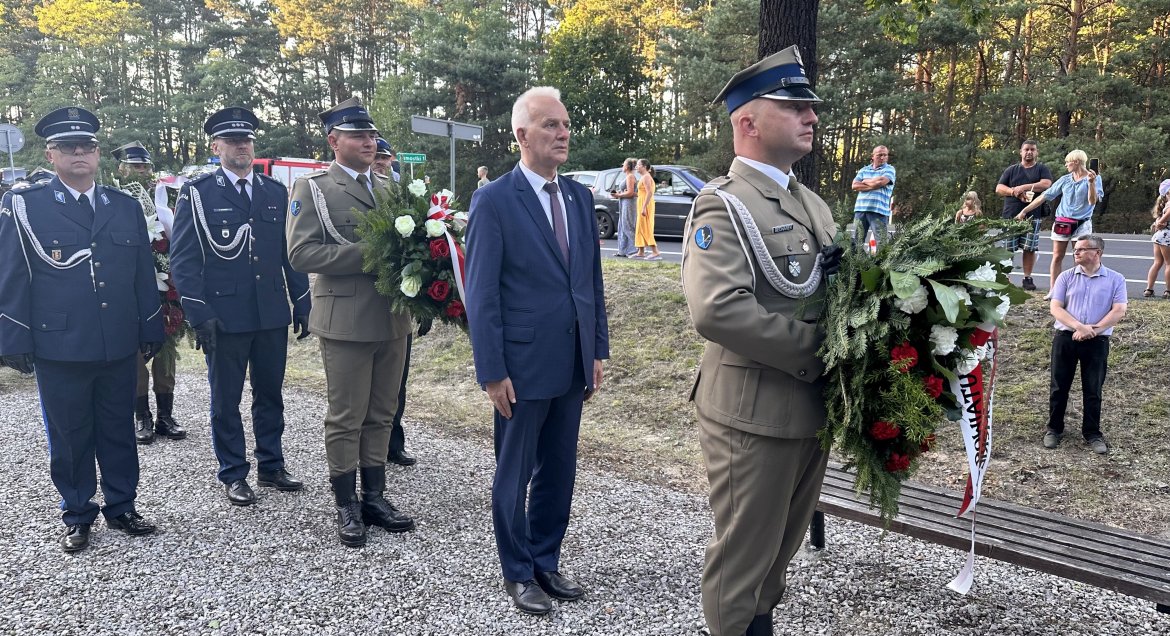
[996,139,1052,291]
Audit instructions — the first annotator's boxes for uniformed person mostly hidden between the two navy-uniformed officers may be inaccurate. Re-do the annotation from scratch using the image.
[111,141,187,444]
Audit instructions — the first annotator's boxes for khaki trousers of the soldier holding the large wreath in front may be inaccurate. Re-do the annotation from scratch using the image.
[698,415,828,636]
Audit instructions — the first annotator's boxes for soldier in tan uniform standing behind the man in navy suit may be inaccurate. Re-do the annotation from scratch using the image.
[287,98,414,546]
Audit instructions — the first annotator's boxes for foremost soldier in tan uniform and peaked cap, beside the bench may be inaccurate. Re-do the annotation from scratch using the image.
[682,47,841,636]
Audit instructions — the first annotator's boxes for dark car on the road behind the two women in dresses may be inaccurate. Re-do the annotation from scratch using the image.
[566,165,711,239]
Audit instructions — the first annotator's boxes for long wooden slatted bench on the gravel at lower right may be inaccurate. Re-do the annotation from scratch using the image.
[810,465,1170,614]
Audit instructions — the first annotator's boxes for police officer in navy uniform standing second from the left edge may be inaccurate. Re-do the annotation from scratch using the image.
[171,106,310,506]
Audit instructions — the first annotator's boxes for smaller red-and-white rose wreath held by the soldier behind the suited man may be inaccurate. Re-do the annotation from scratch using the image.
[357,179,467,330]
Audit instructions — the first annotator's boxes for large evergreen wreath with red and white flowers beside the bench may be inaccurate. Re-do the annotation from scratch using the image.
[820,217,1028,523]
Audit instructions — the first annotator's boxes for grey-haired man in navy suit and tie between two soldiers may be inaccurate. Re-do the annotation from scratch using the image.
[467,87,610,614]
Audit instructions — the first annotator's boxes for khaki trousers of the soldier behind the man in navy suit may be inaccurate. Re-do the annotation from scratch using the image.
[318,336,406,477]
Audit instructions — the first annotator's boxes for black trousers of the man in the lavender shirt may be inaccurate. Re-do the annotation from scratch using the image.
[1048,330,1109,440]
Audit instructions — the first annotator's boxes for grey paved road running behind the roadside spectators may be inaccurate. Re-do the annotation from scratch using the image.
[601,233,1163,298]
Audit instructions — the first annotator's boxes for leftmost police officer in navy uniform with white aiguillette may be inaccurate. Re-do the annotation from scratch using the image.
[0,106,164,552]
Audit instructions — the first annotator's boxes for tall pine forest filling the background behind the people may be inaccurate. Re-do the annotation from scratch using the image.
[0,0,1170,231]
